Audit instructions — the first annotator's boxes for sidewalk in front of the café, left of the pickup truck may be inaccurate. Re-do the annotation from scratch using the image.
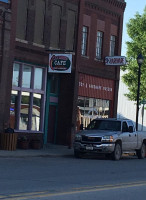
[0,144,73,158]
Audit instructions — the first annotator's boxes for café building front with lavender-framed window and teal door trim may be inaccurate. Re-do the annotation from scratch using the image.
[10,0,79,143]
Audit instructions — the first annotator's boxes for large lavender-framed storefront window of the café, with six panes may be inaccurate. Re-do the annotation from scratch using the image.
[10,62,47,131]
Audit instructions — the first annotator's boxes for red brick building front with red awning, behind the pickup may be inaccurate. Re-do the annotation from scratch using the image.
[76,0,126,133]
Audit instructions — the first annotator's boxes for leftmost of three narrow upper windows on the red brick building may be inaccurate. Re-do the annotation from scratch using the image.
[81,26,88,56]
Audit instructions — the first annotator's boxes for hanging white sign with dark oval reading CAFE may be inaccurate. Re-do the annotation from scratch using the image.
[48,54,72,73]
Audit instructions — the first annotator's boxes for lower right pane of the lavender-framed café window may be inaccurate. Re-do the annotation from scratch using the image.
[31,94,41,131]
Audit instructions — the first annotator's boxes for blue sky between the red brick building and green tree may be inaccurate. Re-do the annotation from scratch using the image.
[121,0,146,56]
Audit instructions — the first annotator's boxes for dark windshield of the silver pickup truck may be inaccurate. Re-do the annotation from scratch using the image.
[87,120,121,131]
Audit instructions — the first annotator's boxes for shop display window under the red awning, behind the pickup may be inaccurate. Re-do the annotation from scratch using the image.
[78,97,110,127]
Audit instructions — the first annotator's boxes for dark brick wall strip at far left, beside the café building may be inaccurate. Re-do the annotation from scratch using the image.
[0,0,14,132]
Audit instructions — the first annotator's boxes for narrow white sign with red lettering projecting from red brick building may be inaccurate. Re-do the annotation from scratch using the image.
[105,56,126,65]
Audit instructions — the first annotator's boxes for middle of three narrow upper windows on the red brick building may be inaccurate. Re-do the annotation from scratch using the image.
[96,31,103,60]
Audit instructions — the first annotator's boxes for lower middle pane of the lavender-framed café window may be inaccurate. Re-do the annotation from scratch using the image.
[19,92,30,130]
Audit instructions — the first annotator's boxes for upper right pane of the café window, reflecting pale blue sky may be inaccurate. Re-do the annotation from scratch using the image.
[34,68,43,90]
